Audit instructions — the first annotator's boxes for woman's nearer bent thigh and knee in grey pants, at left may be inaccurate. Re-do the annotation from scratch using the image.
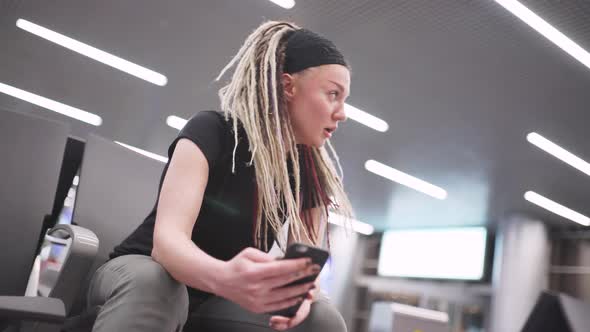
[88,255,189,332]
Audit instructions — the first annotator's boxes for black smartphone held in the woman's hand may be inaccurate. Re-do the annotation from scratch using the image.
[269,243,330,318]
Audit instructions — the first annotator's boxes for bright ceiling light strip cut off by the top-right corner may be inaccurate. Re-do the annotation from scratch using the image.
[496,0,590,68]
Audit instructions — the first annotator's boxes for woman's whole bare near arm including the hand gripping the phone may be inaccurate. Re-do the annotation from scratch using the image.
[152,139,314,313]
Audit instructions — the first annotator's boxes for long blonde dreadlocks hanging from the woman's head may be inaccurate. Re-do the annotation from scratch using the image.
[217,21,352,250]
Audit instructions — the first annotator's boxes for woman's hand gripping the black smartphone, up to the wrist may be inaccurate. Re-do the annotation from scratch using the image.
[214,248,320,313]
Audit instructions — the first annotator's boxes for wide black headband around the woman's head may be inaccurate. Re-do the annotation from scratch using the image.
[283,29,348,74]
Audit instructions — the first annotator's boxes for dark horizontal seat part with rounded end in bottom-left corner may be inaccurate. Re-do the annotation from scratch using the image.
[0,296,66,324]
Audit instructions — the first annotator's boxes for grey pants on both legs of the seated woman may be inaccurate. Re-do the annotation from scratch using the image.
[88,255,346,332]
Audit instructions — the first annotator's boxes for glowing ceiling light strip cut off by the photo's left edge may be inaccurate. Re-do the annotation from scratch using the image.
[0,83,102,126]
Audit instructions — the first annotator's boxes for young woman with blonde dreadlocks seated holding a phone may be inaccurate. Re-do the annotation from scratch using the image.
[88,22,352,332]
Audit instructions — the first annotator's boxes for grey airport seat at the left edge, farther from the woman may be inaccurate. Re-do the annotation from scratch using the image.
[0,110,69,331]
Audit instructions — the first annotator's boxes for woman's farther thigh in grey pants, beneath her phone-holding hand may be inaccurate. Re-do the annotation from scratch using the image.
[184,295,346,332]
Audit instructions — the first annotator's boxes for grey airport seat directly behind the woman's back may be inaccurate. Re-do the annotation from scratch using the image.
[63,134,165,331]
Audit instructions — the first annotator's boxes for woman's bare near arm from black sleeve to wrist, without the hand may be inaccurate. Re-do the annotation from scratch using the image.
[152,139,223,292]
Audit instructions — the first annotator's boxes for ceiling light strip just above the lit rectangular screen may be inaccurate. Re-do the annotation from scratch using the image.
[365,160,447,199]
